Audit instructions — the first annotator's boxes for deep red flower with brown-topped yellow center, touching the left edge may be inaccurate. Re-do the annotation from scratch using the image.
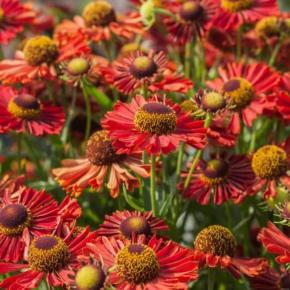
[0,86,65,136]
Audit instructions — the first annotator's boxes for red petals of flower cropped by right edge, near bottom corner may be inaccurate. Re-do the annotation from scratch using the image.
[258,222,290,264]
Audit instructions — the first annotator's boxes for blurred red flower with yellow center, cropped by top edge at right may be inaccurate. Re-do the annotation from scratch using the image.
[212,0,279,31]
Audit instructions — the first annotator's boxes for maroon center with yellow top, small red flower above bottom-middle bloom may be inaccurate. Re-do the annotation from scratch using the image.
[120,216,151,238]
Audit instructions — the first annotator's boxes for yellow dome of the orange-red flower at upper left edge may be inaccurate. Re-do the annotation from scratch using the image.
[23,36,59,66]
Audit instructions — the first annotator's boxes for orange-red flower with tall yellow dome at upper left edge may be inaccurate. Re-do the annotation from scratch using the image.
[0,35,90,84]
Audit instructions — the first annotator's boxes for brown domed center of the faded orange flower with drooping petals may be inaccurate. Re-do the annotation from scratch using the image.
[86,130,125,166]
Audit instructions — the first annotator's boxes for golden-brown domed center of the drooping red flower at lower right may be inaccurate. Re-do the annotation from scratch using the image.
[194,225,236,257]
